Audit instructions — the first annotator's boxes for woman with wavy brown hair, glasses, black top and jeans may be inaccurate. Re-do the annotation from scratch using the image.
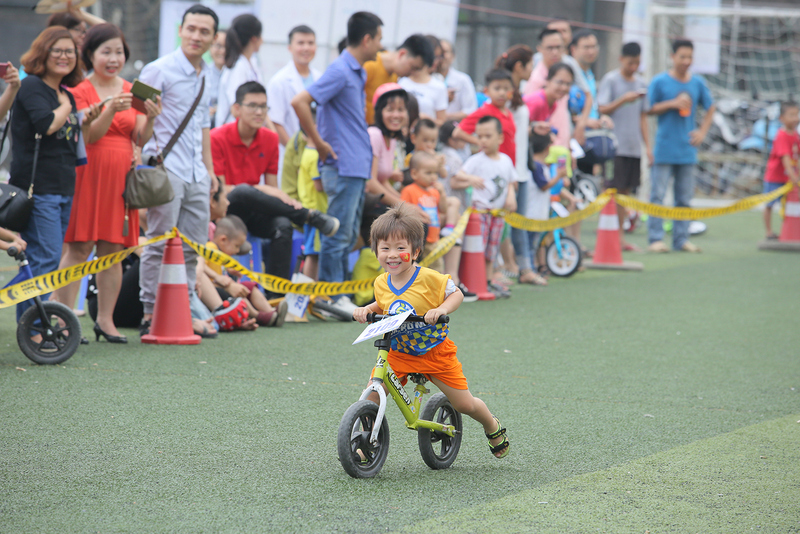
[9,26,97,320]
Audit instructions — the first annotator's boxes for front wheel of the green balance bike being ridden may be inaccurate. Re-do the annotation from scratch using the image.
[336,400,389,478]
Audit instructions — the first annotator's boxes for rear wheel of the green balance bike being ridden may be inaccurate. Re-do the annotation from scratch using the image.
[417,393,461,469]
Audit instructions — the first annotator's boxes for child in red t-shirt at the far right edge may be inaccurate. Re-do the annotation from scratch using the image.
[764,102,800,239]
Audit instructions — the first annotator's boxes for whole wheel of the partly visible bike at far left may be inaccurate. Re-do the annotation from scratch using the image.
[17,300,81,365]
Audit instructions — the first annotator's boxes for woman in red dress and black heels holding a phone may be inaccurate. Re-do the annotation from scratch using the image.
[55,24,161,343]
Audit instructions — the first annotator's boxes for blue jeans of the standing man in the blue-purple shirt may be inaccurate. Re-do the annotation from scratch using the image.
[319,165,367,294]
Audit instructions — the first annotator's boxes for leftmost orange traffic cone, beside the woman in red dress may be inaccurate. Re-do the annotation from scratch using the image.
[142,237,200,345]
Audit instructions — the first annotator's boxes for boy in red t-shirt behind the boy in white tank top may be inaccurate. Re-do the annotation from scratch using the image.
[453,69,517,163]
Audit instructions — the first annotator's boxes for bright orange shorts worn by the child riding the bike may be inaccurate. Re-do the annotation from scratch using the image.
[382,338,468,389]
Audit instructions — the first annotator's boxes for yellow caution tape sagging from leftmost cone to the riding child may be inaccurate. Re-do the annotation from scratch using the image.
[180,239,375,296]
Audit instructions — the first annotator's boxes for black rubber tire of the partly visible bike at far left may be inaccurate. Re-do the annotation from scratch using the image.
[17,300,81,365]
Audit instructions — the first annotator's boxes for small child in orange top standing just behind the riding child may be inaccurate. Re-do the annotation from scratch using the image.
[400,150,447,273]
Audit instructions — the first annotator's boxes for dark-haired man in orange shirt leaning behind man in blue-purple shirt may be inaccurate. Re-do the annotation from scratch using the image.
[364,33,433,125]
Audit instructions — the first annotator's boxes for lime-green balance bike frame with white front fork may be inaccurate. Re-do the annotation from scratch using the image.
[359,332,456,444]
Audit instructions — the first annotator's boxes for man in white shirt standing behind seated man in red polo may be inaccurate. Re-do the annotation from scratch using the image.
[267,26,321,147]
